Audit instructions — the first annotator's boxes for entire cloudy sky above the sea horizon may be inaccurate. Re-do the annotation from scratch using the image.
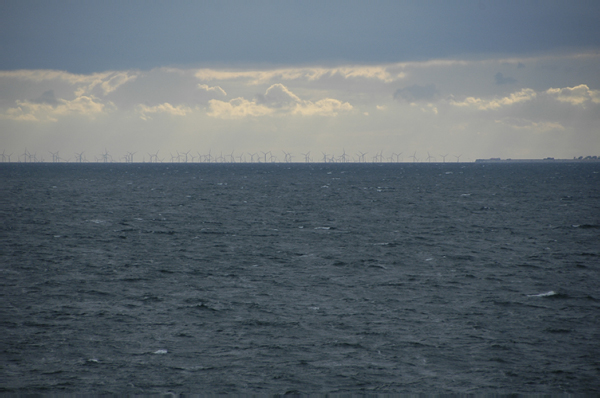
[0,0,600,162]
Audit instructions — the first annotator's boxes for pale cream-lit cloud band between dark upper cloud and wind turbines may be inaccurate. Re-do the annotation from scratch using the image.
[0,53,600,161]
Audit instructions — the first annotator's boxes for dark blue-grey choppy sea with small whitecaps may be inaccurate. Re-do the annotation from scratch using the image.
[0,162,600,396]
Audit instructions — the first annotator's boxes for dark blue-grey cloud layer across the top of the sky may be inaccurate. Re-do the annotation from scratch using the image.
[0,0,600,73]
